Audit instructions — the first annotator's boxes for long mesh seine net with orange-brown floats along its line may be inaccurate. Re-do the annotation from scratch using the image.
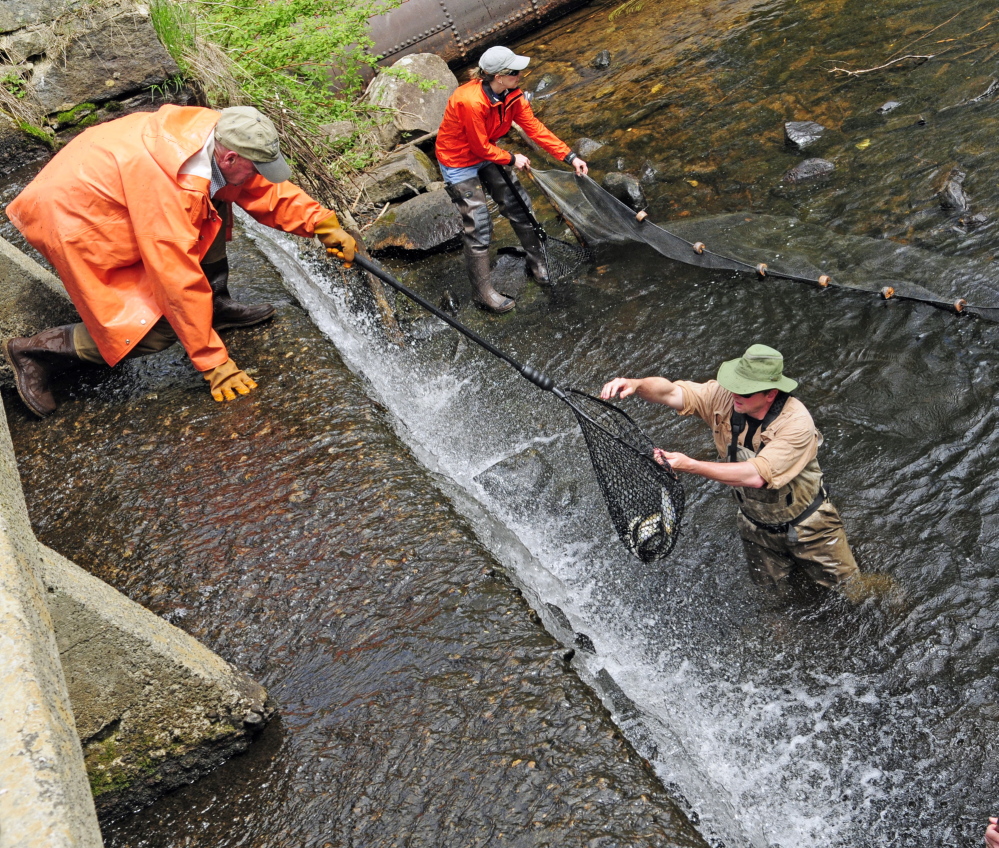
[531,170,999,321]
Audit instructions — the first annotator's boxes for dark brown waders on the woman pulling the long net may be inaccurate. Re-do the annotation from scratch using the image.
[446,163,548,312]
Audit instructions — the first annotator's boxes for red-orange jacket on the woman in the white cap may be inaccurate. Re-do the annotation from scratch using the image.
[437,79,569,168]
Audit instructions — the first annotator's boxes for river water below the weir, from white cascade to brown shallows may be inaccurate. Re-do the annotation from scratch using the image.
[246,0,999,848]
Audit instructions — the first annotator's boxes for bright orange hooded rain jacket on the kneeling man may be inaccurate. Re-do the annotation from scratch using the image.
[7,105,333,371]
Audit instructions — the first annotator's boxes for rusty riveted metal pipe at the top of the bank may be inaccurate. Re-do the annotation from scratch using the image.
[368,0,589,65]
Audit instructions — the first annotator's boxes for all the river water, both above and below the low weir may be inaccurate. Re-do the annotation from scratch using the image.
[5,0,999,848]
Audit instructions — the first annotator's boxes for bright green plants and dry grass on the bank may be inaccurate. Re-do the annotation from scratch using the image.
[151,0,399,202]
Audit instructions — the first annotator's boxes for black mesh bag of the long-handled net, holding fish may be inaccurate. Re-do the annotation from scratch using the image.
[563,389,684,562]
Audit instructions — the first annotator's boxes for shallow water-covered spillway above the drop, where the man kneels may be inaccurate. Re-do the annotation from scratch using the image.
[4,227,703,848]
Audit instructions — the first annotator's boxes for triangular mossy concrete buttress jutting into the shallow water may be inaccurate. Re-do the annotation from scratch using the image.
[40,545,274,818]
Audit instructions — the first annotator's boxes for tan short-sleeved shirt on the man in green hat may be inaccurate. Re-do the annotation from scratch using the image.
[675,380,822,489]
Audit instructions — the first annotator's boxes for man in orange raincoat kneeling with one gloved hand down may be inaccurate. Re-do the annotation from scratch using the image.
[3,105,354,417]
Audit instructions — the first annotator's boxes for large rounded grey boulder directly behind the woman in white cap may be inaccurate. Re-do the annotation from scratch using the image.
[367,53,458,150]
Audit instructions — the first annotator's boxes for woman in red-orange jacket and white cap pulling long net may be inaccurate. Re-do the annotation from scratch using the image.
[437,47,587,312]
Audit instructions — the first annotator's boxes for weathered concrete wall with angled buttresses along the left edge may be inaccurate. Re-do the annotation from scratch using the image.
[0,234,274,836]
